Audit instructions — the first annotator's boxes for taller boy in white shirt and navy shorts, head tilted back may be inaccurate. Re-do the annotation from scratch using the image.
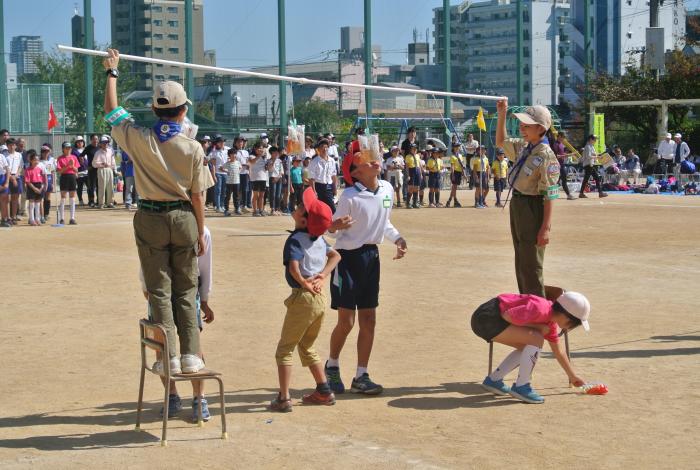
[325,152,407,395]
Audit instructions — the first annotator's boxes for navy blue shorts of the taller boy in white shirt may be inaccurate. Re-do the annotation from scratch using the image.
[331,245,379,310]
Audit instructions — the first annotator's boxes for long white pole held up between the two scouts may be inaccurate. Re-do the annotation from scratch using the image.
[58,44,505,101]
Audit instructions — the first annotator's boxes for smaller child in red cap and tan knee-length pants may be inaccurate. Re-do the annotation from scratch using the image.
[270,188,340,412]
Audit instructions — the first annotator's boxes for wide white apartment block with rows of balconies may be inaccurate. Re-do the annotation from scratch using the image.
[433,0,571,105]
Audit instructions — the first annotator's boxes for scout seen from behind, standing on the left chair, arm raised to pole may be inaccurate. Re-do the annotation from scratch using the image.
[102,49,214,373]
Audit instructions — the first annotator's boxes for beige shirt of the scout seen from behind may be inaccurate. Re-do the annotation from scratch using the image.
[112,119,214,201]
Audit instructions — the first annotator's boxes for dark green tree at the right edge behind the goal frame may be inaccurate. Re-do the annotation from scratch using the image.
[586,50,700,155]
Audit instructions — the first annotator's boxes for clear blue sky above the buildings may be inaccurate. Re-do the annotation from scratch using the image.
[4,0,442,68]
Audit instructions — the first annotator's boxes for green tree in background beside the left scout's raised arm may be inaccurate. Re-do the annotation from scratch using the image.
[26,49,136,133]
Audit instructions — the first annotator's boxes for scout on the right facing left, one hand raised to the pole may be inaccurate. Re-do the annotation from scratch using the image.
[496,99,559,297]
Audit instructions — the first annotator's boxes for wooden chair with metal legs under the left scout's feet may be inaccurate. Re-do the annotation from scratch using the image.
[135,319,228,447]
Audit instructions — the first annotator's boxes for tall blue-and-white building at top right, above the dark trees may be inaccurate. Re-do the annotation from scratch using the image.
[562,0,686,102]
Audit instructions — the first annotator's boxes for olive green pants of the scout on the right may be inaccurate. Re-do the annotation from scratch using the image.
[510,194,545,297]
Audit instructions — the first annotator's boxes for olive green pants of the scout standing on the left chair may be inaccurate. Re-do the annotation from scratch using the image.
[134,208,199,357]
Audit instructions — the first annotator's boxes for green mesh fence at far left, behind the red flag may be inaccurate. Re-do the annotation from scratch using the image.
[7,83,66,134]
